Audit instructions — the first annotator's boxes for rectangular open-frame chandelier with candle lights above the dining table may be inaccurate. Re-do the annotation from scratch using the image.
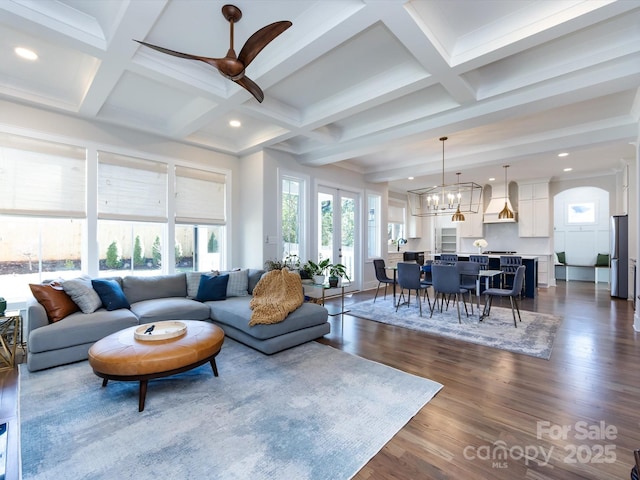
[407,137,482,222]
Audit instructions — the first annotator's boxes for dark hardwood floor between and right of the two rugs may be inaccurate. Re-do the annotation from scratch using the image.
[321,282,640,480]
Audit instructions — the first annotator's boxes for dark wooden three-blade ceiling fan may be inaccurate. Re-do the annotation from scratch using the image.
[134,5,292,103]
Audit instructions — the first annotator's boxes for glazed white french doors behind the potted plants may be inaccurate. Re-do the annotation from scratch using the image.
[316,186,360,291]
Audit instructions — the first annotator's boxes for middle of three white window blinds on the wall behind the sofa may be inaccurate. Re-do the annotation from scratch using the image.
[98,152,168,222]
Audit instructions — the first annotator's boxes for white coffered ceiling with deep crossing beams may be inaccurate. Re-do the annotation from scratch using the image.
[0,0,640,191]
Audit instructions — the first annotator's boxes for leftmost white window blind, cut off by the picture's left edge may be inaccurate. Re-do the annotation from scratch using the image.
[0,133,87,218]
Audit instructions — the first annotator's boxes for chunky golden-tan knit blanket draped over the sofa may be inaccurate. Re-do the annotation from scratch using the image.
[249,270,304,326]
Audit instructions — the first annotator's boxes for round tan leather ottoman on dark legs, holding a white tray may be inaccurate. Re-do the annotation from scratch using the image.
[89,320,224,412]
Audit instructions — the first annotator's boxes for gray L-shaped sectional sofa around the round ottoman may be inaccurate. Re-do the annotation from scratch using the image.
[25,269,330,371]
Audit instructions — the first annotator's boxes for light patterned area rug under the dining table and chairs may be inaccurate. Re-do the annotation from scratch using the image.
[348,296,561,360]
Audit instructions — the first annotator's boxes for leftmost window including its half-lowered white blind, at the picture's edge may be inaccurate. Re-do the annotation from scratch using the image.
[0,133,86,301]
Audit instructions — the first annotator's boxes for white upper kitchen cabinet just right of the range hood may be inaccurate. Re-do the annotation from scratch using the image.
[518,181,550,237]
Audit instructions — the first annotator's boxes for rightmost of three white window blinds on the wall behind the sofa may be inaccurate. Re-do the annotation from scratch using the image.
[176,166,226,225]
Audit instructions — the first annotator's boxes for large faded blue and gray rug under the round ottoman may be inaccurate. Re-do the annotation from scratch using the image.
[20,339,442,480]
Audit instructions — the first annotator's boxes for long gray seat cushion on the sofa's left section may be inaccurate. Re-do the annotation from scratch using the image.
[28,308,138,354]
